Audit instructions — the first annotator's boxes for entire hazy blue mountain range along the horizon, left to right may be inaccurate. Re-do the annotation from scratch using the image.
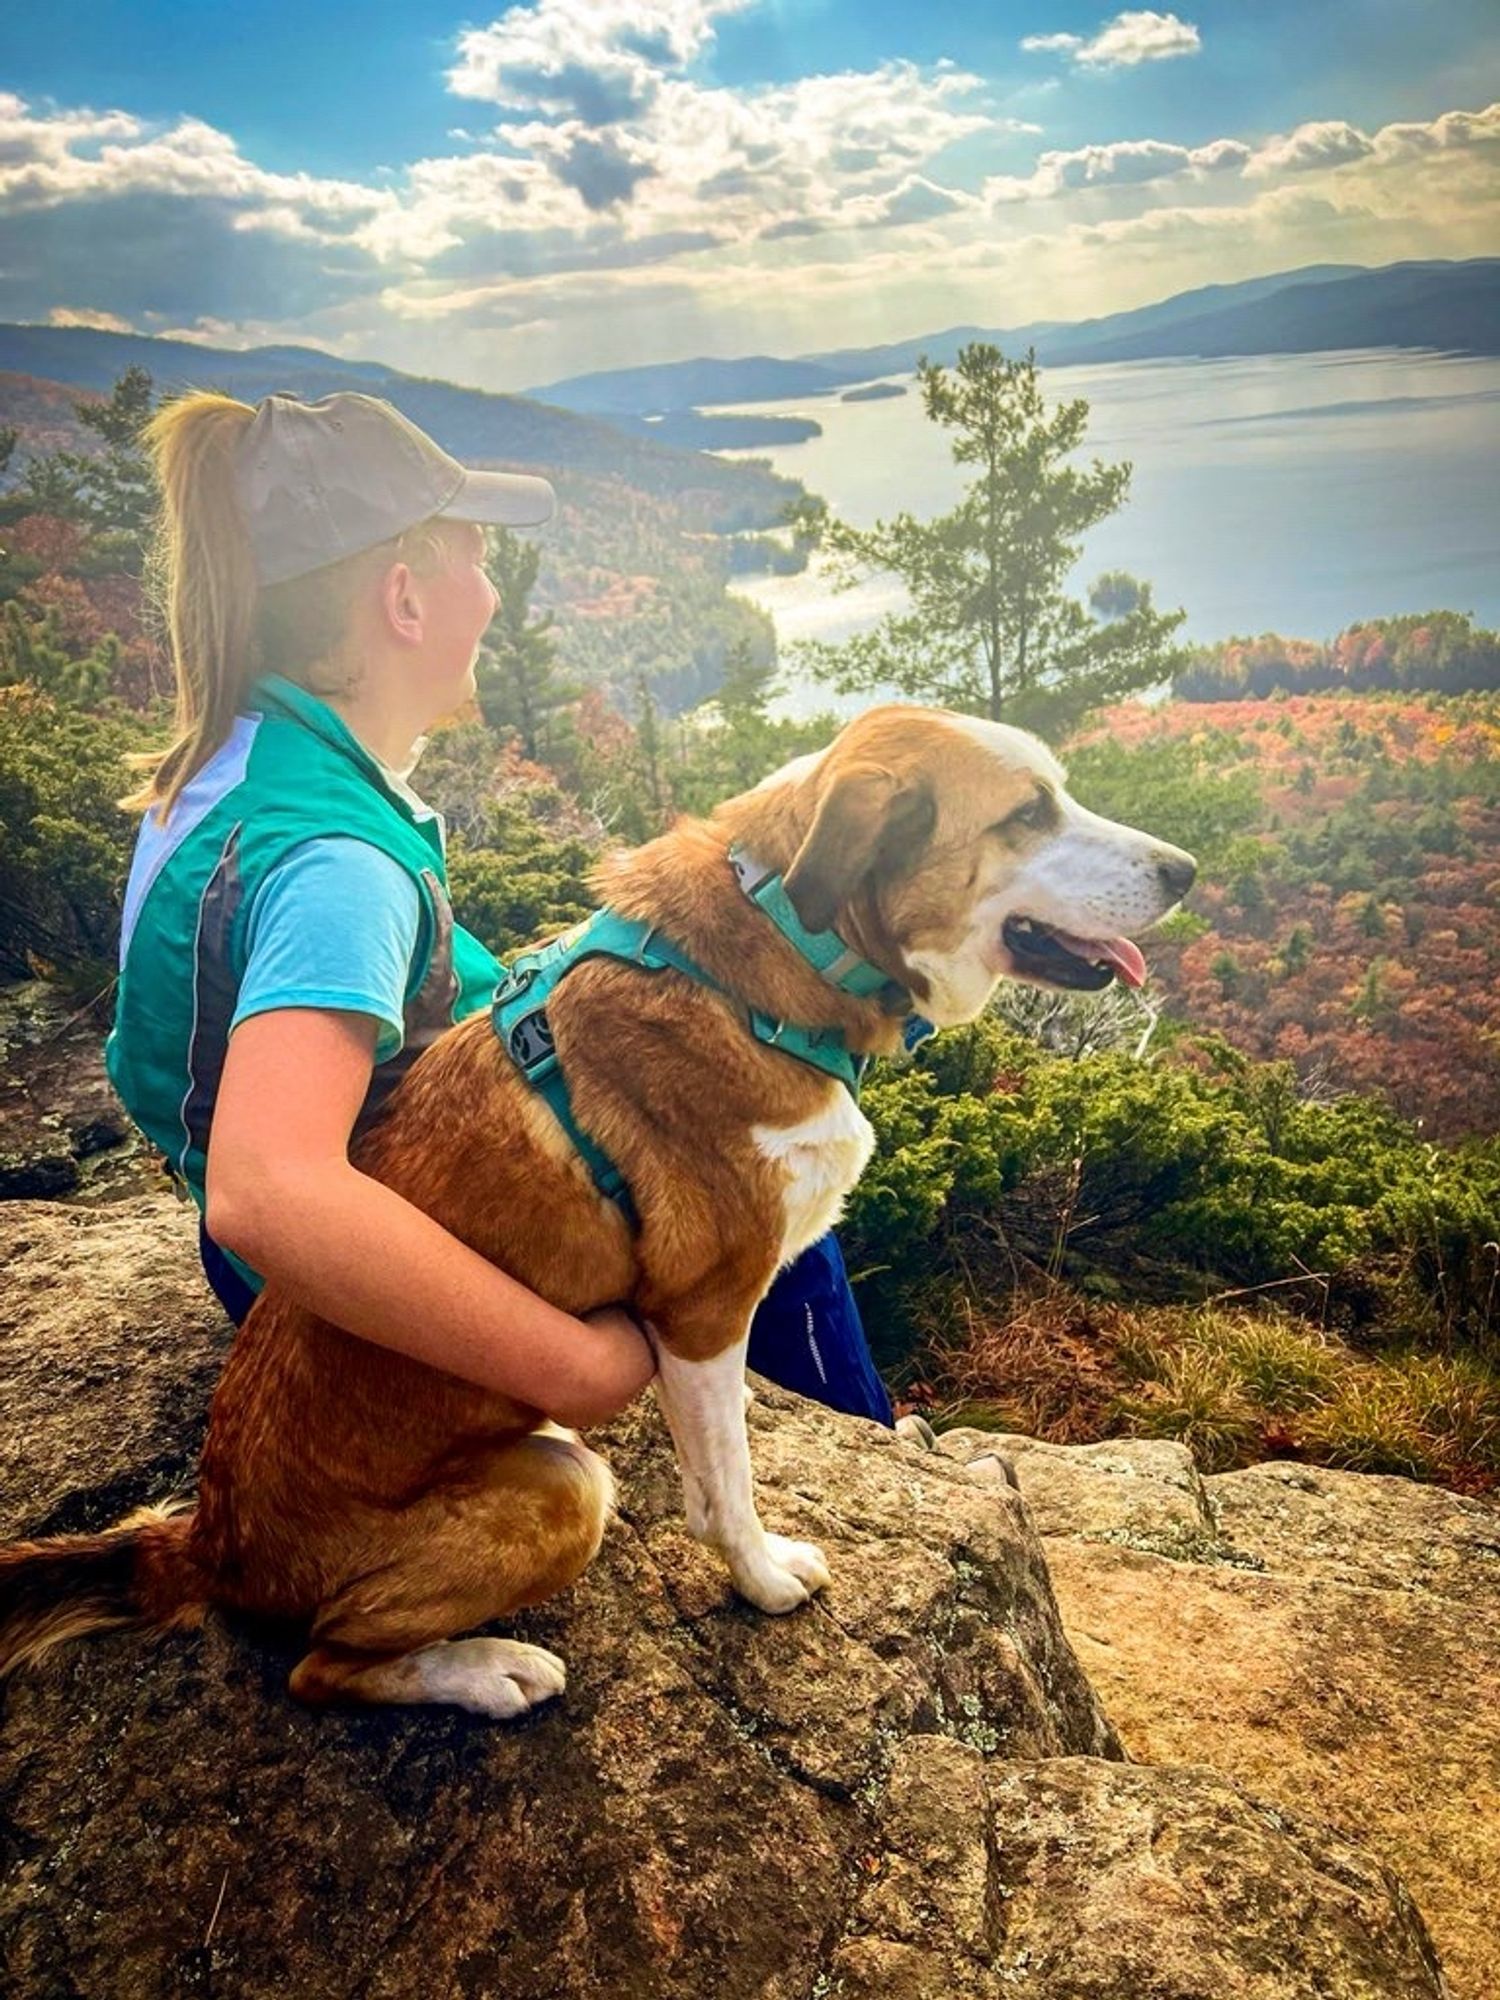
[0,258,1500,474]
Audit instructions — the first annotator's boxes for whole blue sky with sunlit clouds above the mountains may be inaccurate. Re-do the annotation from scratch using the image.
[0,0,1500,388]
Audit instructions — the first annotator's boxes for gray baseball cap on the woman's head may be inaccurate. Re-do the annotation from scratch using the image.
[234,390,556,584]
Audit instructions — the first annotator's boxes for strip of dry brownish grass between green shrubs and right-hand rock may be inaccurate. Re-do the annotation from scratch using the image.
[928,1286,1500,1492]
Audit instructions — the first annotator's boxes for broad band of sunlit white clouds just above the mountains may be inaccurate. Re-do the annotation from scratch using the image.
[0,55,1500,388]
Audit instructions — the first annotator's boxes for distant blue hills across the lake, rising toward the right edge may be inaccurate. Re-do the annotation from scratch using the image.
[530,258,1500,416]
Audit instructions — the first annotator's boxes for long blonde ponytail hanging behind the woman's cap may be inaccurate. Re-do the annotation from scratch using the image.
[122,392,258,818]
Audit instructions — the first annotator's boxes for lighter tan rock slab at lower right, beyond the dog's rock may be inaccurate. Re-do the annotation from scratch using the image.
[940,1432,1500,2000]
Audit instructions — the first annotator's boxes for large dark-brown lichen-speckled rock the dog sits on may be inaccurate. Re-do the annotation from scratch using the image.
[0,1196,1444,2000]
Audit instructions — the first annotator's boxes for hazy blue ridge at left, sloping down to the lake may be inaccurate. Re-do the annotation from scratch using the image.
[0,324,796,530]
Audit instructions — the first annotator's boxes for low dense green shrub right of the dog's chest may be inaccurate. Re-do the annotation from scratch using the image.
[846,1018,1500,1368]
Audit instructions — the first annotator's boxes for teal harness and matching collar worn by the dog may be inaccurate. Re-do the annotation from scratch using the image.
[492,848,932,1228]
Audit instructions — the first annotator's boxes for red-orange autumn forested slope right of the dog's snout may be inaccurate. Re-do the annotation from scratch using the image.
[1072,694,1500,1138]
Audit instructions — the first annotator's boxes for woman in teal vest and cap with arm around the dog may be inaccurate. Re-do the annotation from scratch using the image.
[106,394,890,1426]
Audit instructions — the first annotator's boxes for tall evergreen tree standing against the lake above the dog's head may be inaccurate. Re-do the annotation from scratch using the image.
[804,342,1184,732]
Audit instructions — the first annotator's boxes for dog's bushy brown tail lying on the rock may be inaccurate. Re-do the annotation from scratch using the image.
[0,1500,208,1680]
